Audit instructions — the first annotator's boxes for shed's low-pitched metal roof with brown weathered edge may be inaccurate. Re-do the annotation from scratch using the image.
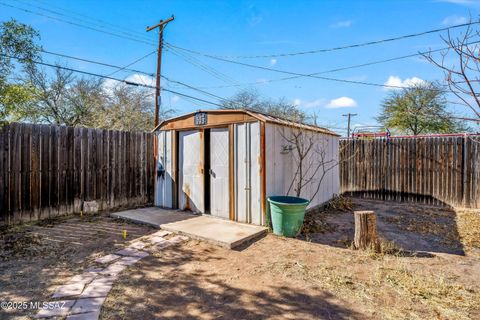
[153,109,340,136]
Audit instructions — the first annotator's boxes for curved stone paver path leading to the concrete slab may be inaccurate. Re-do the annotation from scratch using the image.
[35,231,188,320]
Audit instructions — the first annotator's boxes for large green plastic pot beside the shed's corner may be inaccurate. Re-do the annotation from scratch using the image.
[268,196,310,237]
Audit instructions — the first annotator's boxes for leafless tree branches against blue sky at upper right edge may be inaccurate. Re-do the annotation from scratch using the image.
[424,26,480,119]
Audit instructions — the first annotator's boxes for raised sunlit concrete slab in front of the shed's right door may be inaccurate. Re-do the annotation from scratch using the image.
[161,216,267,249]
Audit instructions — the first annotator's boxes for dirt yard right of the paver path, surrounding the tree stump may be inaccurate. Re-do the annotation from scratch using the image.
[101,199,480,319]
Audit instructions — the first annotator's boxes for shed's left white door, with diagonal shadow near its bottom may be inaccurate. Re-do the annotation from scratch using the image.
[178,130,205,213]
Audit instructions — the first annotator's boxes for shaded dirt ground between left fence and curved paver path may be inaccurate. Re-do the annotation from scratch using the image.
[0,211,155,319]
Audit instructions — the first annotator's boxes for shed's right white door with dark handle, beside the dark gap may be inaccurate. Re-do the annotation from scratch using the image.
[210,128,230,219]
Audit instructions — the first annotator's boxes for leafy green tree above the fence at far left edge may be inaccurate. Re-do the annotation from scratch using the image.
[0,19,40,123]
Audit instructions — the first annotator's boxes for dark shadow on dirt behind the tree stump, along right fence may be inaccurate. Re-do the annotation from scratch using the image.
[299,198,465,257]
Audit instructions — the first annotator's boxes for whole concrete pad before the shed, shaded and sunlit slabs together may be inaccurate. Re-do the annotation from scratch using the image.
[111,207,268,249]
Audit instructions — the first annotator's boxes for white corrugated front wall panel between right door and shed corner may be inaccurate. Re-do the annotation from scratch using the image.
[234,122,264,225]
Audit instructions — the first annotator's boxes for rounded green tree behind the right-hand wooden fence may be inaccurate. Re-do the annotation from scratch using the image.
[377,83,466,135]
